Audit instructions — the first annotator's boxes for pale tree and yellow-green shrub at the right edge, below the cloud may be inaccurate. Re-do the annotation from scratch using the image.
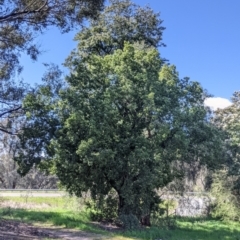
[211,92,240,220]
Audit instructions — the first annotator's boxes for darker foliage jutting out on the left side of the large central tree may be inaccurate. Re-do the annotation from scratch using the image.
[15,65,64,175]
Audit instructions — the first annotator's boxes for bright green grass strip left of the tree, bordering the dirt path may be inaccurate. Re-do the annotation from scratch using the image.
[0,208,103,233]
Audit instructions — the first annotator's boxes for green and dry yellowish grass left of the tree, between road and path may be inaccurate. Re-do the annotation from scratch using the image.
[0,196,102,233]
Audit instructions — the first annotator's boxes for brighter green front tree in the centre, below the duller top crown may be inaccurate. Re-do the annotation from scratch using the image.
[53,43,215,223]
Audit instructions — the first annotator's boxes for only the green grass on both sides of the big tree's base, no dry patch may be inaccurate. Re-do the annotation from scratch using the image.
[0,208,240,240]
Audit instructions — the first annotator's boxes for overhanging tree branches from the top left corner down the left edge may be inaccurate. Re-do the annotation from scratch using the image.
[0,0,104,134]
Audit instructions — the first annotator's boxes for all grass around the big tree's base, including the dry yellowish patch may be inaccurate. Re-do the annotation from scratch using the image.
[0,197,240,240]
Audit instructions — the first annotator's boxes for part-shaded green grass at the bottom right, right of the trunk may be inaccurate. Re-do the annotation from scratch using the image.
[120,218,240,240]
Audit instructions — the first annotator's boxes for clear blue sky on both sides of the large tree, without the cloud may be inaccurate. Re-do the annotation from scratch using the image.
[22,0,240,99]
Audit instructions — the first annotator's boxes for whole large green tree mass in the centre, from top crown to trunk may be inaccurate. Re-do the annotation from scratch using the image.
[16,0,222,224]
